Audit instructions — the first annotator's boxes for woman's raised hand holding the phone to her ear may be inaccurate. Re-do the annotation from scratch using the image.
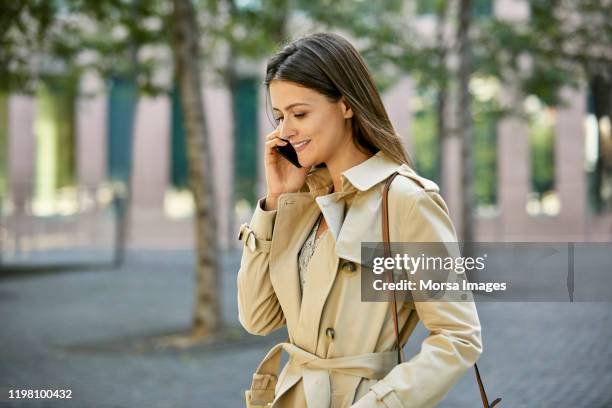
[264,125,308,210]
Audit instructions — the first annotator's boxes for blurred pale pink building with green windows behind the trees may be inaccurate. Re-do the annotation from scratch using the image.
[0,0,612,262]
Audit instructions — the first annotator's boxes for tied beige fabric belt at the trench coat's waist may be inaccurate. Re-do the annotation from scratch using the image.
[250,343,397,408]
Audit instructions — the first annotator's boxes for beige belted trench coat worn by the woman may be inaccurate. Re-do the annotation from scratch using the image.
[237,152,482,408]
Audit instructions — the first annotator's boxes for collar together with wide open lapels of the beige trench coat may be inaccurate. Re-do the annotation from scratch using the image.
[270,148,435,342]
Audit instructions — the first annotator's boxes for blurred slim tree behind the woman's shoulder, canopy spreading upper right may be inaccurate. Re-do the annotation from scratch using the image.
[332,0,612,237]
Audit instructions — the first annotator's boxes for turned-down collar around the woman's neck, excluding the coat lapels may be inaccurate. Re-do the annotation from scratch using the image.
[303,150,400,197]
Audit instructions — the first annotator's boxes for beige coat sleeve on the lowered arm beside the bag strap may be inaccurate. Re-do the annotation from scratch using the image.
[353,190,482,408]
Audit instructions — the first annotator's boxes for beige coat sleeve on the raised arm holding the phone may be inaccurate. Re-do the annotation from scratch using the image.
[237,199,285,335]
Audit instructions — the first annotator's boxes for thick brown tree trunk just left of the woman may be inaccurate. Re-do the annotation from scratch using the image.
[173,0,221,337]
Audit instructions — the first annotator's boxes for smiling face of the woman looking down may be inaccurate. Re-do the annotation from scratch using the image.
[270,80,353,168]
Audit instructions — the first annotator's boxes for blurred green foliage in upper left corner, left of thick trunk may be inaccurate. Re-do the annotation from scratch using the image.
[0,0,168,92]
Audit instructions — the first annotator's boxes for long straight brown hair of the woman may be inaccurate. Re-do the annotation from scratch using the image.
[264,33,411,165]
